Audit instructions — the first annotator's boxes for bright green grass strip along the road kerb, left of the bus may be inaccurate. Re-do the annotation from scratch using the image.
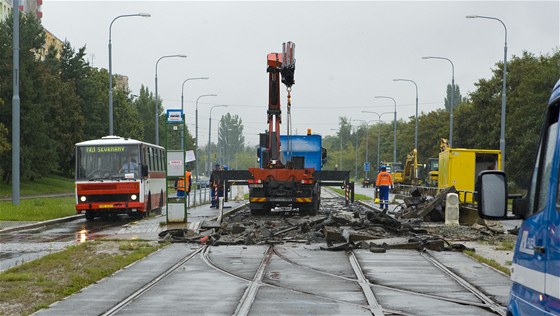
[0,197,76,221]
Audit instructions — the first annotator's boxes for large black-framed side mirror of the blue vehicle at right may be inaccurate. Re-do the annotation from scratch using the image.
[476,170,508,219]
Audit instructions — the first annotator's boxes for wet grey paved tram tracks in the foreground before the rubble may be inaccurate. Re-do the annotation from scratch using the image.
[34,186,504,316]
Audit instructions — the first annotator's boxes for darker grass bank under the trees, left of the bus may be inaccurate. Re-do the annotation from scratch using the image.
[0,176,74,197]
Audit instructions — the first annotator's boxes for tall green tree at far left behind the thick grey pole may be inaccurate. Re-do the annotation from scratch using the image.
[0,14,58,182]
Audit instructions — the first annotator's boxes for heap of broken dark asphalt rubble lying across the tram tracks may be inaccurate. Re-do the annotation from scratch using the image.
[156,199,512,252]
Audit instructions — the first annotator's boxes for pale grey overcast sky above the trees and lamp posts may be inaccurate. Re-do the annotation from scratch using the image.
[42,0,560,144]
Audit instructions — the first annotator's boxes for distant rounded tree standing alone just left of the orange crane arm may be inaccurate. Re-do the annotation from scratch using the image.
[218,113,245,168]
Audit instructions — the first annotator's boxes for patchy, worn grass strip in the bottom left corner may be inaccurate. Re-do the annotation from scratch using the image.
[0,241,162,315]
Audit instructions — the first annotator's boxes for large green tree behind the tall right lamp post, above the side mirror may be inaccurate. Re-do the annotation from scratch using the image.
[458,50,560,187]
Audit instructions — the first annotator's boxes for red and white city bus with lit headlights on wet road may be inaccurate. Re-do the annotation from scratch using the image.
[75,136,166,221]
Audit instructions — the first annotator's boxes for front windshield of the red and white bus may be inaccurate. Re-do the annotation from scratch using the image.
[76,145,140,181]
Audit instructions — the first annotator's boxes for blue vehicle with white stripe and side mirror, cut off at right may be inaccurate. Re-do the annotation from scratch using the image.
[477,80,560,316]
